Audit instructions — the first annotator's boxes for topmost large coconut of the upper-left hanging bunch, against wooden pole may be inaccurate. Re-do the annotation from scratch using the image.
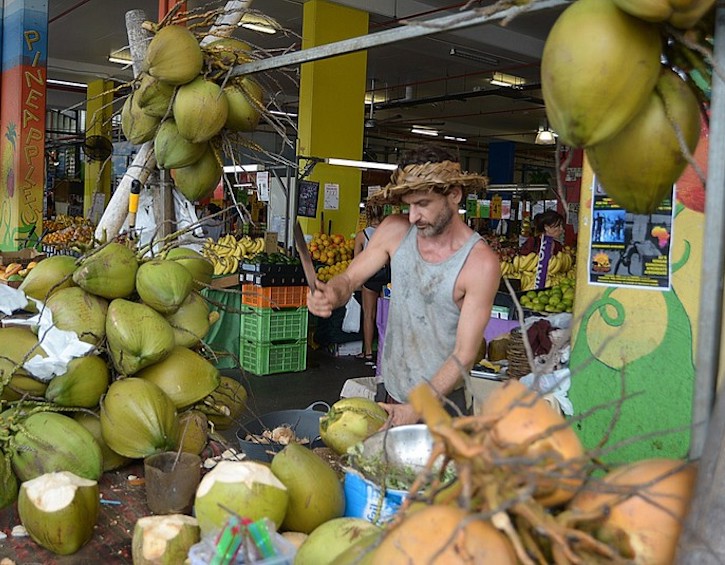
[143,25,204,84]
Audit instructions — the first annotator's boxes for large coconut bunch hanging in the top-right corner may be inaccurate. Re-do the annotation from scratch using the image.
[541,0,714,214]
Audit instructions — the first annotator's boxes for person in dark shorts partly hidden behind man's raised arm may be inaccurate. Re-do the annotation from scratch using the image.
[353,204,390,365]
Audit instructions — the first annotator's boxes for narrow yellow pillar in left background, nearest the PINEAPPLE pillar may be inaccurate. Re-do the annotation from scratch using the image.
[83,80,113,217]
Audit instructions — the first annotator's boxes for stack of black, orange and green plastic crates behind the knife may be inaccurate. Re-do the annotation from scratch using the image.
[239,263,307,375]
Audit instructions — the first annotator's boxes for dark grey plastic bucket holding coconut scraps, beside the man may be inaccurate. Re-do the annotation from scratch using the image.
[236,401,330,461]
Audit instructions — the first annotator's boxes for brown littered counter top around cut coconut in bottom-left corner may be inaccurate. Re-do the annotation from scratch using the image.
[0,462,151,565]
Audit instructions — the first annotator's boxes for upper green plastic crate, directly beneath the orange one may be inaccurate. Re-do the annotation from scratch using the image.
[240,306,307,343]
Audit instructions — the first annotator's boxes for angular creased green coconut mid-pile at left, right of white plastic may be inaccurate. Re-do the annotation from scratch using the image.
[106,298,175,375]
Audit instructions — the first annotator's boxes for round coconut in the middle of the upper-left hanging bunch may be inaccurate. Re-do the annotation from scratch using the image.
[174,76,229,143]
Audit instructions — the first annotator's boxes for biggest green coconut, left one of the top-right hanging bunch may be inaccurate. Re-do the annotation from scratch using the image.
[541,0,662,147]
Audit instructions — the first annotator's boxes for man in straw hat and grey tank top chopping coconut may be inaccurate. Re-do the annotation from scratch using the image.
[308,146,500,426]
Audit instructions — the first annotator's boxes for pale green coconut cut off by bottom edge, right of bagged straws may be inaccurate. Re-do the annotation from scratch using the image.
[295,518,381,565]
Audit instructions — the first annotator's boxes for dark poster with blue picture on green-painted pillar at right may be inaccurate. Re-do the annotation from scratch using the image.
[589,177,674,290]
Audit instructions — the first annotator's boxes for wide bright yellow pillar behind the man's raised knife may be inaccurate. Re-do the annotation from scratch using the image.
[297,0,368,235]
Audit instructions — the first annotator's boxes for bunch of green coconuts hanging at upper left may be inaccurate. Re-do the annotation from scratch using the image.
[121,10,276,201]
